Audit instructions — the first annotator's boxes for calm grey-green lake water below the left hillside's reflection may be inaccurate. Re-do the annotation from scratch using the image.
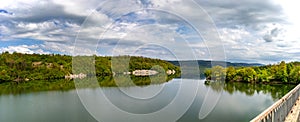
[0,79,294,122]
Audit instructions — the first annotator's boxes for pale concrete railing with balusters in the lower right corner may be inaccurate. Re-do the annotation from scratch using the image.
[251,84,300,122]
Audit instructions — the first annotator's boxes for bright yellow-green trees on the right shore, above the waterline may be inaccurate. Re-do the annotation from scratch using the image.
[204,61,300,84]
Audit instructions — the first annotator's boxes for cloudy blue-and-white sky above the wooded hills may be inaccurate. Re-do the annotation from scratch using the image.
[0,0,300,64]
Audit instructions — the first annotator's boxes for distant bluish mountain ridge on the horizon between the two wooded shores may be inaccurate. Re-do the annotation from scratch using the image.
[168,60,263,67]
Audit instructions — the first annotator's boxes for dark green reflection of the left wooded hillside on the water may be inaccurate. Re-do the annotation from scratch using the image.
[0,75,176,95]
